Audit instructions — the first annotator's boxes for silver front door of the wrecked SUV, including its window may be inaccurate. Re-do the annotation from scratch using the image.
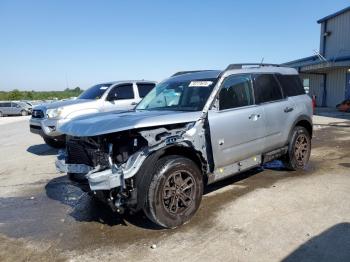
[208,75,265,168]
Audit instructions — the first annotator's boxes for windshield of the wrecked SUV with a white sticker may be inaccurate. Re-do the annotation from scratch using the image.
[136,79,215,111]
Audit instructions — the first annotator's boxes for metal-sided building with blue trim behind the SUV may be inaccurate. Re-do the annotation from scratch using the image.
[284,6,350,107]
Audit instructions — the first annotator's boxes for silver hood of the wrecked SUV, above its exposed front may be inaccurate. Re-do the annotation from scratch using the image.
[59,111,202,137]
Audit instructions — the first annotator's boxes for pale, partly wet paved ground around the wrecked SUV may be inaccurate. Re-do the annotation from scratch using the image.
[0,117,350,261]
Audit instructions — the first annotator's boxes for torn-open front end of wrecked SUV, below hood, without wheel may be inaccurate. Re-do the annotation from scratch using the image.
[56,119,210,212]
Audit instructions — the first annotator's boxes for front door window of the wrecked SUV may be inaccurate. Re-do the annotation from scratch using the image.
[219,75,254,110]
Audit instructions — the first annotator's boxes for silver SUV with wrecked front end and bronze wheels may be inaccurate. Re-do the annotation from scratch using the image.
[56,64,312,228]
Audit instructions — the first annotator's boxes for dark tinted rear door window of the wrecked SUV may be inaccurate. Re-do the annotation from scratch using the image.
[254,74,283,104]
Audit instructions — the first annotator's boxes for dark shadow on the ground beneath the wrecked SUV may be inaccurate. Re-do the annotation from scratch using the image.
[45,161,287,230]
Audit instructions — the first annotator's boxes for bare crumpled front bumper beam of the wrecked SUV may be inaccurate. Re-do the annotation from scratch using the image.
[55,153,124,191]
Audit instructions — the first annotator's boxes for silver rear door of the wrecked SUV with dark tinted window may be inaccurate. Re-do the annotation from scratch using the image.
[253,74,295,152]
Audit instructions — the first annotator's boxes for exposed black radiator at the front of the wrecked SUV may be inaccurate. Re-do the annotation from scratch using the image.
[66,139,108,167]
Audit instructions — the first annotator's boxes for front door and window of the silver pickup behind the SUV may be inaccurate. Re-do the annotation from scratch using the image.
[104,83,137,111]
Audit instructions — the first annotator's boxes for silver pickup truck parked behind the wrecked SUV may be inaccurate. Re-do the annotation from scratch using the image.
[29,80,156,148]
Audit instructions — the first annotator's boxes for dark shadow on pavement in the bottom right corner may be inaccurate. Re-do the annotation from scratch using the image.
[283,223,350,262]
